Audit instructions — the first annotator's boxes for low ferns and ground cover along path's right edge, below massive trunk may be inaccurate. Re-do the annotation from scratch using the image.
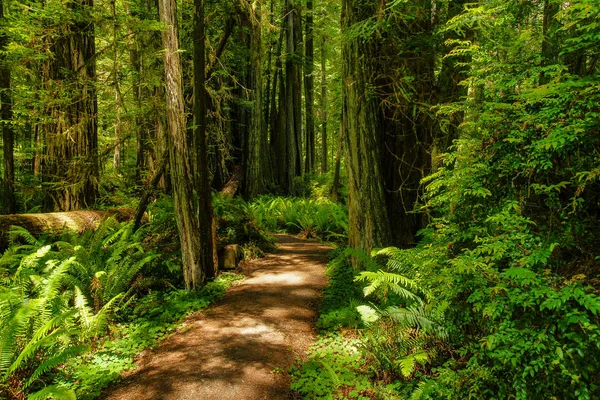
[292,248,447,399]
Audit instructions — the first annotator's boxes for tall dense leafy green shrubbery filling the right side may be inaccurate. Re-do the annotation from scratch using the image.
[390,1,600,399]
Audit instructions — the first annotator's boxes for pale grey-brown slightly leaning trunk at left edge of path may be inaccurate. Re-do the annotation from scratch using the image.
[158,0,206,290]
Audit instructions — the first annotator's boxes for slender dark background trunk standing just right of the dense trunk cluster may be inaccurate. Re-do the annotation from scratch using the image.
[304,0,316,173]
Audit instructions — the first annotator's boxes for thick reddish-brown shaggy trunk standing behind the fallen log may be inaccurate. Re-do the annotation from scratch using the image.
[42,0,99,211]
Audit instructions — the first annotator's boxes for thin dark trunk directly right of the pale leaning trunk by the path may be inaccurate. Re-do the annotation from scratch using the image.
[194,0,218,279]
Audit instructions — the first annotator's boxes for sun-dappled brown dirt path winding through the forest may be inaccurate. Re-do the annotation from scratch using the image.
[104,235,330,400]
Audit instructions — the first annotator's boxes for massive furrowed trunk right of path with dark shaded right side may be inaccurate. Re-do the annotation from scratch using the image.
[342,0,435,250]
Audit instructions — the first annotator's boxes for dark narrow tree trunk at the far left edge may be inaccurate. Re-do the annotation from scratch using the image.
[0,0,17,214]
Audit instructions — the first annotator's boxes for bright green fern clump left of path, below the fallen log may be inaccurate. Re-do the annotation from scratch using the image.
[0,221,158,398]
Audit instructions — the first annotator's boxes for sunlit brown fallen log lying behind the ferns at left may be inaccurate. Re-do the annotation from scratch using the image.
[0,208,135,251]
